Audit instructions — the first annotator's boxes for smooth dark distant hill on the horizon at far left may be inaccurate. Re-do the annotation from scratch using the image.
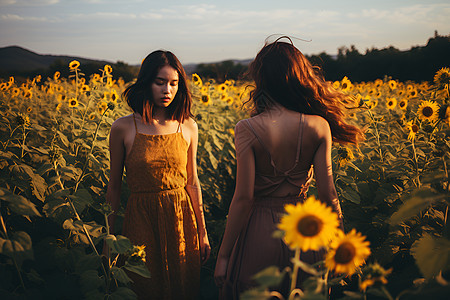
[0,46,112,72]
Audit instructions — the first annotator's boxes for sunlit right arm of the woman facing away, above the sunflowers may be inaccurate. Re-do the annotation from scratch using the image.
[313,119,342,222]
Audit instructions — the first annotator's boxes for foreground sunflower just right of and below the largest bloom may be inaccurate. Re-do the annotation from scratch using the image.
[325,229,370,275]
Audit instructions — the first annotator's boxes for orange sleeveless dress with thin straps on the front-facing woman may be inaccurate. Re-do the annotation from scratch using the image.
[123,115,201,299]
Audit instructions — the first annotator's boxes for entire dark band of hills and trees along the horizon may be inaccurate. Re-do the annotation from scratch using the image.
[0,32,450,82]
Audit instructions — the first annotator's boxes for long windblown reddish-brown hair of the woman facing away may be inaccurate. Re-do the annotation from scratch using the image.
[248,37,364,144]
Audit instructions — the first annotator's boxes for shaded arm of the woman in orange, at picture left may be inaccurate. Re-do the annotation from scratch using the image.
[106,119,126,232]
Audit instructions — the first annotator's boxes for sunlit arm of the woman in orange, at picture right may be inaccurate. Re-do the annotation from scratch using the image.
[186,119,211,263]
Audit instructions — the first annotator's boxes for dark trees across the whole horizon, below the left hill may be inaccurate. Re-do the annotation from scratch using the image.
[4,32,450,82]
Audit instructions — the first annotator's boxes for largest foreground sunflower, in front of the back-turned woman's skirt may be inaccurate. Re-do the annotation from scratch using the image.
[278,196,339,251]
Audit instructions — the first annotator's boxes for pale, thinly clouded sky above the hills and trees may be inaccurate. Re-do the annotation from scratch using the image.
[0,0,450,64]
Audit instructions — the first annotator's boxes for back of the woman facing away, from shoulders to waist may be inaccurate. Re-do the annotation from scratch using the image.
[236,106,328,197]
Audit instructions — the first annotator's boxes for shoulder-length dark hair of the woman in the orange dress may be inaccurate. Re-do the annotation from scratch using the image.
[122,50,193,123]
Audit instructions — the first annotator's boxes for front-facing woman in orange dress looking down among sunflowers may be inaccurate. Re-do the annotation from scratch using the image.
[106,51,210,299]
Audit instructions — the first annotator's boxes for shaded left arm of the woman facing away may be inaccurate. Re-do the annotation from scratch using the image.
[214,122,255,286]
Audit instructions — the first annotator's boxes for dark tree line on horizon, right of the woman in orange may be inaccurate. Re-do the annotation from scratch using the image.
[195,32,450,82]
